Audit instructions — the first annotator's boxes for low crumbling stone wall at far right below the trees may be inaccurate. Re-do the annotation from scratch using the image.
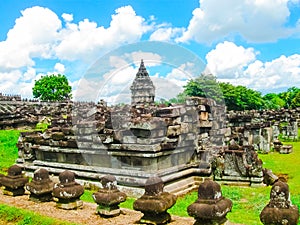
[225,108,300,152]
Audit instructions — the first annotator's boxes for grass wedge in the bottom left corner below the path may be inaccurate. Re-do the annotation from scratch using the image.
[0,204,75,225]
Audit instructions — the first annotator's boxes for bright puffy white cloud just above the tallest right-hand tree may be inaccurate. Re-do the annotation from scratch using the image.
[206,41,258,78]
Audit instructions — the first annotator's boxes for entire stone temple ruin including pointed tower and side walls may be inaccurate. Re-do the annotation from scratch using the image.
[0,61,300,196]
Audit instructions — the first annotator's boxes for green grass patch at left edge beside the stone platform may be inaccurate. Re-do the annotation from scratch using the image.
[0,130,20,173]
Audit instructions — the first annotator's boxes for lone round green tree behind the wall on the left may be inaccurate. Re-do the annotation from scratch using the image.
[32,74,72,101]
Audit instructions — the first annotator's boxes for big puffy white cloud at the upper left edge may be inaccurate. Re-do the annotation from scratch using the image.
[0,6,61,70]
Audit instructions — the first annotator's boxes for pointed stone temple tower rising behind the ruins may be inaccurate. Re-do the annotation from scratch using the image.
[130,60,155,105]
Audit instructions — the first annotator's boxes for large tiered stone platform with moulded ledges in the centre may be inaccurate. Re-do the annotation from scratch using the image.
[18,98,213,194]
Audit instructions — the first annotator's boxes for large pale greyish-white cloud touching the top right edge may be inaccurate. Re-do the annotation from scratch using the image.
[177,0,296,43]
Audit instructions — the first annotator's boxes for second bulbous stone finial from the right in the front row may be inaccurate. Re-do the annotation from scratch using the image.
[187,180,232,225]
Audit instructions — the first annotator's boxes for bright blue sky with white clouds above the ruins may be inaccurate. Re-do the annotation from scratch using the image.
[0,0,300,101]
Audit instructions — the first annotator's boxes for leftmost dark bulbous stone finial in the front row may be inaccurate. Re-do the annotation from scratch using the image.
[0,165,29,196]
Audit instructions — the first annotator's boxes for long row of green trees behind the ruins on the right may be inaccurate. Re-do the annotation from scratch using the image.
[171,74,300,111]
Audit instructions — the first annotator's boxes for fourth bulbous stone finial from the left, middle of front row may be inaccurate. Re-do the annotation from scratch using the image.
[93,175,127,217]
